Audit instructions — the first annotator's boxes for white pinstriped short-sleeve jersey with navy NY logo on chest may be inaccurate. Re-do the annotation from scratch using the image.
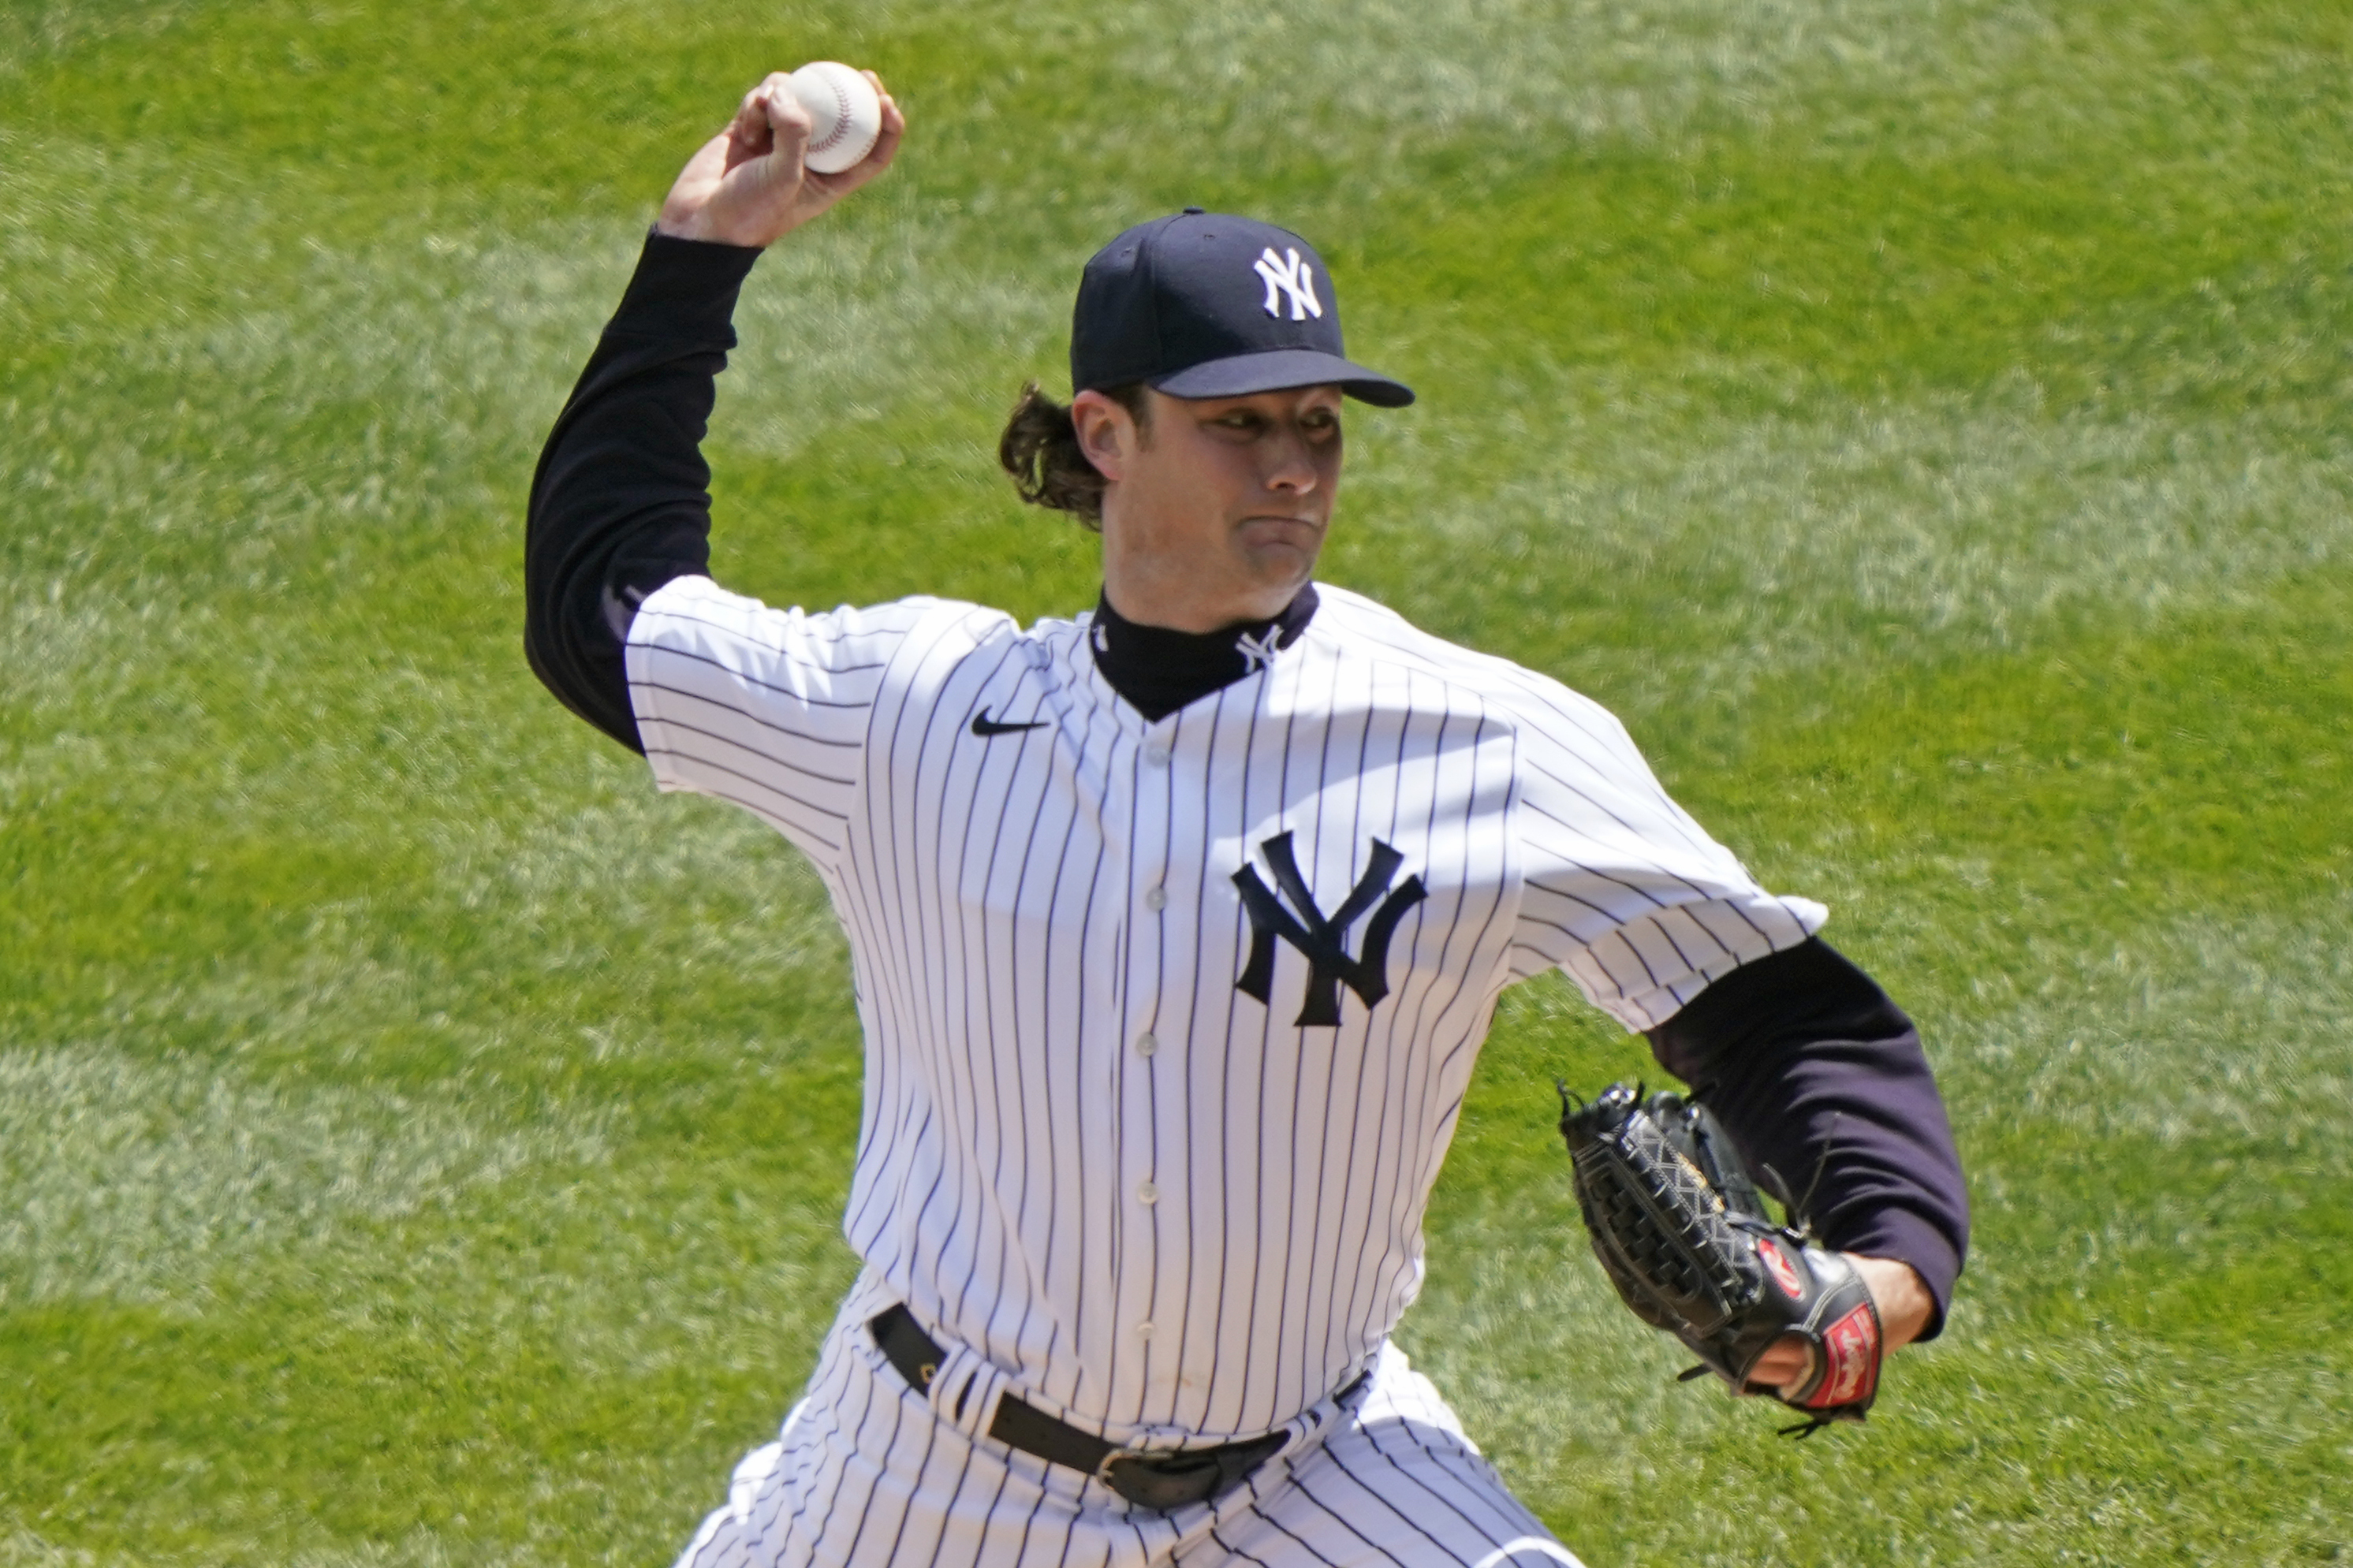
[628,579,1824,1443]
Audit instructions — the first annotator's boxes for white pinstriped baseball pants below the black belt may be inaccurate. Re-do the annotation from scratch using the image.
[677,1324,1576,1568]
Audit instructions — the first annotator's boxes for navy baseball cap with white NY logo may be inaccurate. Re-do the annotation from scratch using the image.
[1071,207,1414,409]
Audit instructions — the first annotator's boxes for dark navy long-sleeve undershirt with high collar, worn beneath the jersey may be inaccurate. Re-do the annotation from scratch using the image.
[522,235,1970,1335]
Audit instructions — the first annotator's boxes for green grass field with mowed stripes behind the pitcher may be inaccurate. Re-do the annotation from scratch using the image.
[0,0,2353,1568]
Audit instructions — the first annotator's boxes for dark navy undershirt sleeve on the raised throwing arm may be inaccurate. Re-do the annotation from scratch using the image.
[522,235,760,752]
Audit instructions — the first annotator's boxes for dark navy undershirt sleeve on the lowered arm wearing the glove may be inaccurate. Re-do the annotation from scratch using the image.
[1650,938,1970,1338]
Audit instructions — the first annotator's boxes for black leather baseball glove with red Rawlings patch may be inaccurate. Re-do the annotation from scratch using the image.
[1560,1084,1882,1436]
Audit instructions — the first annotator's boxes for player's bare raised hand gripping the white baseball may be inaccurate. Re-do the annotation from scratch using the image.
[654,70,906,249]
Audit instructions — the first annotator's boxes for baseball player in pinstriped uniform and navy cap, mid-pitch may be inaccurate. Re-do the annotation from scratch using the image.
[527,75,1967,1568]
